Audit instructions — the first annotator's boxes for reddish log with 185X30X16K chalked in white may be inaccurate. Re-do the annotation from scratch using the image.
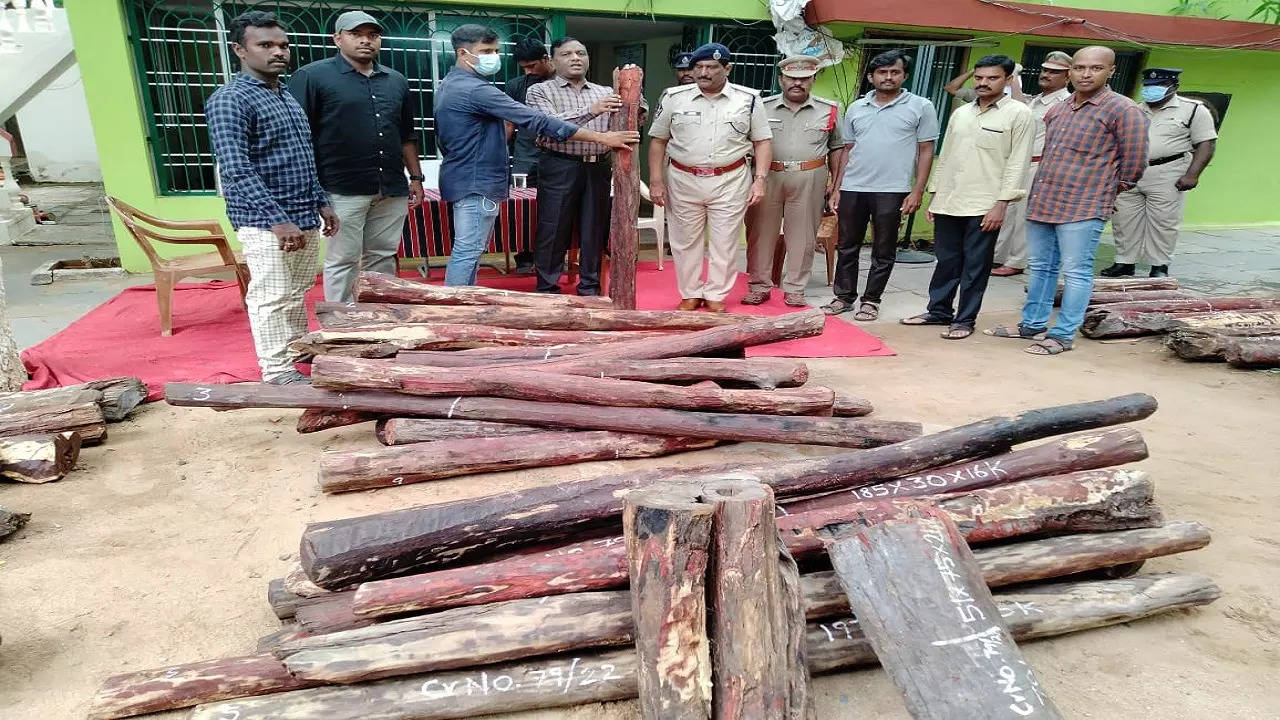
[782,427,1147,512]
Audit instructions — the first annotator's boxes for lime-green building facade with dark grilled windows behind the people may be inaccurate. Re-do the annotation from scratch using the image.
[65,0,1280,272]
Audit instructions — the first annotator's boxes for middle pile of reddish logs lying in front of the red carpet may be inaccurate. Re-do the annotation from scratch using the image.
[165,273,920,493]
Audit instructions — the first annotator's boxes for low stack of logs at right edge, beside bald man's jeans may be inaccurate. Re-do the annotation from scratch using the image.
[1080,278,1280,368]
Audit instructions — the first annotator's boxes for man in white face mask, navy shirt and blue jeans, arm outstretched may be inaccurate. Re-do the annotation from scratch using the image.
[435,24,640,286]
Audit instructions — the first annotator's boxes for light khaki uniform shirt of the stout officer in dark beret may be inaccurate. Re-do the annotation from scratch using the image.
[649,82,773,168]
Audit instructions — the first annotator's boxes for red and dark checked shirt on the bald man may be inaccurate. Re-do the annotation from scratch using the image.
[1027,90,1148,224]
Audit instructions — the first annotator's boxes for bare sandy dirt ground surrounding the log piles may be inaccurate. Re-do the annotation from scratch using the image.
[0,314,1280,720]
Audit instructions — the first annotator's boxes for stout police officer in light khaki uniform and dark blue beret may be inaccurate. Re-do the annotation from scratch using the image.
[649,42,773,313]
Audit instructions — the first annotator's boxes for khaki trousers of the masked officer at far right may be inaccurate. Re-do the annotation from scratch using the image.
[1111,155,1192,265]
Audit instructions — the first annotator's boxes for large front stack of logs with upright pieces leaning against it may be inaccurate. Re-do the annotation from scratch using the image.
[90,391,1220,720]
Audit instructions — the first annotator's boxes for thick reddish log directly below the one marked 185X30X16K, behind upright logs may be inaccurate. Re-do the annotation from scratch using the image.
[352,470,1161,618]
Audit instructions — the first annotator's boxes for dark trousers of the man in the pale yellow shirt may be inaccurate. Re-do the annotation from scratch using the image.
[929,214,1000,328]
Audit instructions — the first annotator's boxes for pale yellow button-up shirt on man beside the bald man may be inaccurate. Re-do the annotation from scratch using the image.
[929,97,1036,217]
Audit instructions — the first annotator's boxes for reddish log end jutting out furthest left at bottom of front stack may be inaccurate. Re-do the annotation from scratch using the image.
[88,653,316,720]
